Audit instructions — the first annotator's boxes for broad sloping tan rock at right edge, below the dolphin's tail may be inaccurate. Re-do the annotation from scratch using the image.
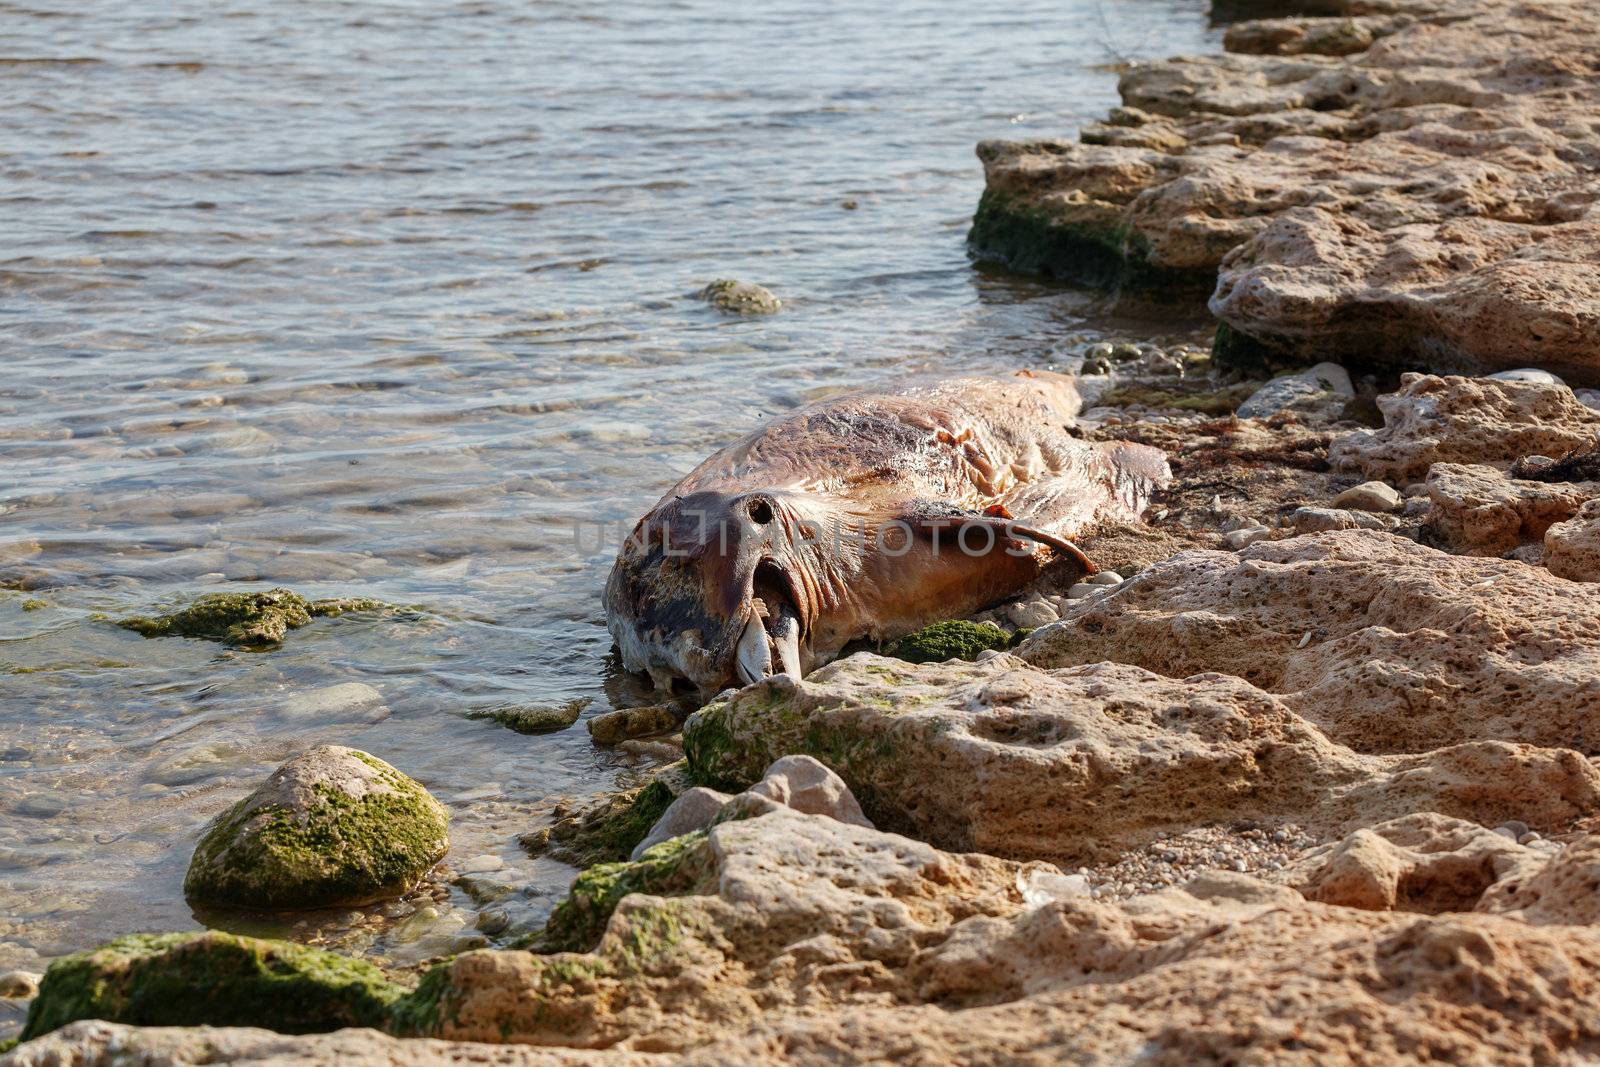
[1018,530,1600,753]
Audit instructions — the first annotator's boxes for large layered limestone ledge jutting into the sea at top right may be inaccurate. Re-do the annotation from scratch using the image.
[971,0,1600,384]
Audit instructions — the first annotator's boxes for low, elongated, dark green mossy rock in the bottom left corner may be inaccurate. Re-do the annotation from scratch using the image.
[21,931,406,1041]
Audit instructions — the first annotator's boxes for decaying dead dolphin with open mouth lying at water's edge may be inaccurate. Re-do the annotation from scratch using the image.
[605,371,1171,693]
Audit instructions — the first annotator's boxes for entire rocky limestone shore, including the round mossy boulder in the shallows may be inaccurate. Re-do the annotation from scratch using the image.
[0,0,1600,1067]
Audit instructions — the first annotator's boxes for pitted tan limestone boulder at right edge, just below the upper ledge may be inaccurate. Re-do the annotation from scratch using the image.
[1328,374,1600,483]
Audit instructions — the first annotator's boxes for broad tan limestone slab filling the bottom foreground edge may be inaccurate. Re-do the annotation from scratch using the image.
[25,811,1600,1067]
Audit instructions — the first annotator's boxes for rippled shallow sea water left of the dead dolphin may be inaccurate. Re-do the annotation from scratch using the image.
[0,0,1216,969]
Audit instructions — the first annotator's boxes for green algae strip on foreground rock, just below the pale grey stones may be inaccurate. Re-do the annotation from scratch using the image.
[517,830,715,953]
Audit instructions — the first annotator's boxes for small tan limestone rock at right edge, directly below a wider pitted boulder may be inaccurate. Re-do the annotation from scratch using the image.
[1427,462,1600,556]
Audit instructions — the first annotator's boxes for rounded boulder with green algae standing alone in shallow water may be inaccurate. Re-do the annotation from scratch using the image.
[184,745,450,910]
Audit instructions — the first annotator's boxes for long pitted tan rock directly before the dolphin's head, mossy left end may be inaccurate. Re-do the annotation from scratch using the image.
[685,653,1600,864]
